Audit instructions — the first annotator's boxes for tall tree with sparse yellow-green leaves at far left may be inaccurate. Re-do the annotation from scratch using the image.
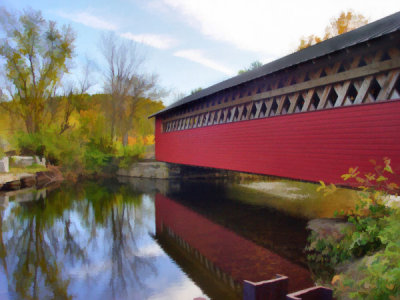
[0,9,75,133]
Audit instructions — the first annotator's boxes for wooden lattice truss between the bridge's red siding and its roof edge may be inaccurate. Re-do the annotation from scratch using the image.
[163,38,400,132]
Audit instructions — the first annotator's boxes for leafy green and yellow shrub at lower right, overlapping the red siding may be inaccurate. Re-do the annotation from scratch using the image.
[307,158,400,299]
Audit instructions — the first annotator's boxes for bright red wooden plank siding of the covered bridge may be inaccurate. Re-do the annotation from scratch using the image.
[156,100,400,184]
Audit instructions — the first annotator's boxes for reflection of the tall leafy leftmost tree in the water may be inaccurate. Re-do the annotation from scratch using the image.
[4,193,72,299]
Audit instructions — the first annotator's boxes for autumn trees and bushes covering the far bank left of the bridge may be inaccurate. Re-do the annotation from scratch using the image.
[0,8,164,174]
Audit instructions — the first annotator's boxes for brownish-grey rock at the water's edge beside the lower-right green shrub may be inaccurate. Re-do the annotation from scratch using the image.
[307,218,354,241]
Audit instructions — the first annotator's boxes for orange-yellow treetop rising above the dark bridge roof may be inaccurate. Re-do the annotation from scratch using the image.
[296,10,368,51]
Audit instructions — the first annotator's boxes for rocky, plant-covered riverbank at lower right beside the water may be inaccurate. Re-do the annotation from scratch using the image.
[306,195,400,299]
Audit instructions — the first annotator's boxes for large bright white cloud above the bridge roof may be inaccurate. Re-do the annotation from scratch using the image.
[153,0,400,56]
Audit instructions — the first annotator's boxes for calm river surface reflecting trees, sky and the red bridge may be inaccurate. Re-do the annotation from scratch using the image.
[0,179,320,299]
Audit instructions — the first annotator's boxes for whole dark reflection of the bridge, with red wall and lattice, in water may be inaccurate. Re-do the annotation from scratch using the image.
[155,185,313,299]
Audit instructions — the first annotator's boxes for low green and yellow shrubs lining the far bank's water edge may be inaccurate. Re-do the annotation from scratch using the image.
[15,129,146,178]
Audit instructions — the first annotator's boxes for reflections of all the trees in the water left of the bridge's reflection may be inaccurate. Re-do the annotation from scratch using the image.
[0,180,156,299]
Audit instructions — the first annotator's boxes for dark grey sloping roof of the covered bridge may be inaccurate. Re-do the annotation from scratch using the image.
[150,12,400,117]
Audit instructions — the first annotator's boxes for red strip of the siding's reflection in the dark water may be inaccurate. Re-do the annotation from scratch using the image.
[155,194,313,291]
